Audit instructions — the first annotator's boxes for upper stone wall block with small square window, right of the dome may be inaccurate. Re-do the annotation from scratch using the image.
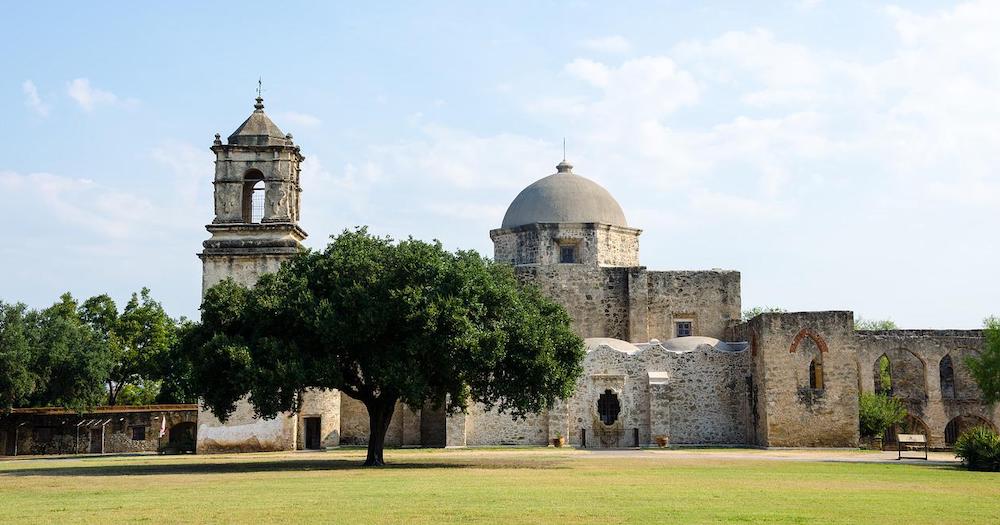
[630,270,740,342]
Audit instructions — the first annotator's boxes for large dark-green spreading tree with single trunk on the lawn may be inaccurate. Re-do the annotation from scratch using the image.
[185,229,584,465]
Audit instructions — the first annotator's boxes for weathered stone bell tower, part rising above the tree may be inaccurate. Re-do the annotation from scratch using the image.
[198,93,306,295]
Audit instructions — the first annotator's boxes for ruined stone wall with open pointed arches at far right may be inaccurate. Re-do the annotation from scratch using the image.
[857,330,1000,448]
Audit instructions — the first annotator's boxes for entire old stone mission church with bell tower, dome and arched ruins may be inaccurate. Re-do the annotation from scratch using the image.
[191,97,1000,452]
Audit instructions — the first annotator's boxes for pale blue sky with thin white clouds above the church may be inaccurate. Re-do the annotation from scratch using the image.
[0,0,1000,328]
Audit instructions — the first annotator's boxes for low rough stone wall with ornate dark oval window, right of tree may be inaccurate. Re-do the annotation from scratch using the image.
[566,339,750,448]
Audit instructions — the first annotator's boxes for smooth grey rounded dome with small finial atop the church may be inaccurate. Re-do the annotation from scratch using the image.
[500,160,628,228]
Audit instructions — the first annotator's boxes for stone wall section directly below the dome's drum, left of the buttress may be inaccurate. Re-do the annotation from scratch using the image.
[515,264,629,339]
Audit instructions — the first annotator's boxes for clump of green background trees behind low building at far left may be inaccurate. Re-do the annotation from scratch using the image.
[0,289,188,411]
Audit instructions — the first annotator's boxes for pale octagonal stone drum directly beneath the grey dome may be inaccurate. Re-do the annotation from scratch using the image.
[490,223,640,266]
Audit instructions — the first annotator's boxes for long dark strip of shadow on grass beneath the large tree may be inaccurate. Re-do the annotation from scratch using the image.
[0,456,558,477]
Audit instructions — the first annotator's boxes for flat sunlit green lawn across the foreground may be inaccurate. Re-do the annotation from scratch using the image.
[0,449,1000,525]
